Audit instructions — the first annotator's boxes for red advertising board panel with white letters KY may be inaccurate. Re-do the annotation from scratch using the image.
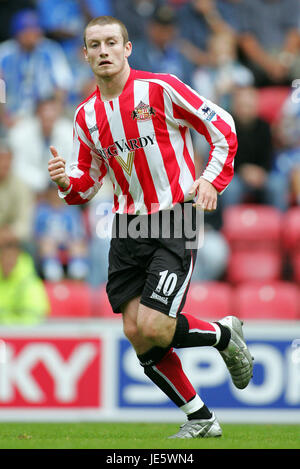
[0,335,102,408]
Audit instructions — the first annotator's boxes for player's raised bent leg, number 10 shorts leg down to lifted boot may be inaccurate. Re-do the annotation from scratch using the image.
[137,241,253,414]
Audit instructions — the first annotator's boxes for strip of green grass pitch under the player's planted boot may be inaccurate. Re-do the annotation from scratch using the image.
[0,423,300,450]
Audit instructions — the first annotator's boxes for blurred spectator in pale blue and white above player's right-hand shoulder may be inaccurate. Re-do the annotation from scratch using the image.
[193,33,254,110]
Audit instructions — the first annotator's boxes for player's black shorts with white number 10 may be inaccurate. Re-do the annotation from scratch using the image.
[106,203,197,318]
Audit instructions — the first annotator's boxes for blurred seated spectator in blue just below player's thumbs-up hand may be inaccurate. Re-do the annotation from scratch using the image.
[34,184,88,281]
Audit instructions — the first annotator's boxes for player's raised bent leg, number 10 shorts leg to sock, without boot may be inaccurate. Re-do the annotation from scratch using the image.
[137,245,230,350]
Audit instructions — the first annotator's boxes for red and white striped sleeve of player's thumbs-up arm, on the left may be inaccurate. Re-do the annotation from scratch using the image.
[58,107,107,205]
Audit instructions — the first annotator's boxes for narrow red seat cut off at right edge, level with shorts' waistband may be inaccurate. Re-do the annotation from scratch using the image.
[282,207,300,253]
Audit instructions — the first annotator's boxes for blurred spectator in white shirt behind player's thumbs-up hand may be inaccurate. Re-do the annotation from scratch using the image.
[8,97,73,194]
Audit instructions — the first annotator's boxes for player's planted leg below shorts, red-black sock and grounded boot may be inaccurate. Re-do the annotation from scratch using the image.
[121,297,222,438]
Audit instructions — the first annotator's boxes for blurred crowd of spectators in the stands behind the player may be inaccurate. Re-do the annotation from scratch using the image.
[0,0,300,323]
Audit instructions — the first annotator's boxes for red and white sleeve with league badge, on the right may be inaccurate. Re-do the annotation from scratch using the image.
[164,75,237,193]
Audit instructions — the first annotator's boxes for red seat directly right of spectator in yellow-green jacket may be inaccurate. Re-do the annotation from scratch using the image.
[45,280,92,318]
